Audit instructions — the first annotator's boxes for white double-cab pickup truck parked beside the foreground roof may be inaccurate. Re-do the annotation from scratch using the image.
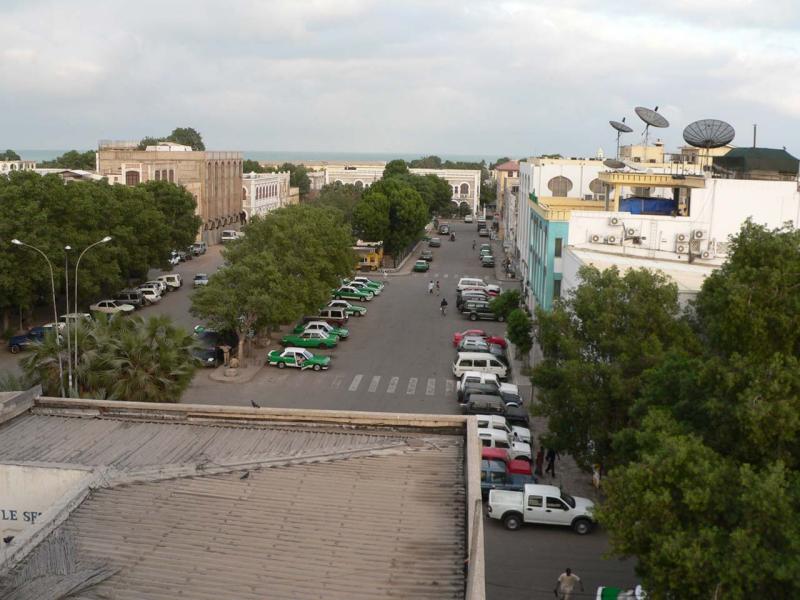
[489,483,594,535]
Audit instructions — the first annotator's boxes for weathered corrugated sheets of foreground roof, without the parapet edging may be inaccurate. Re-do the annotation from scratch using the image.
[0,448,466,600]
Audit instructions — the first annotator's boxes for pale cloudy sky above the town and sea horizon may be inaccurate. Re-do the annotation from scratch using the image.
[0,0,800,157]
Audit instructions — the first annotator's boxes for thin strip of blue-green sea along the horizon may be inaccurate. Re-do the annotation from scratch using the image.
[16,148,500,163]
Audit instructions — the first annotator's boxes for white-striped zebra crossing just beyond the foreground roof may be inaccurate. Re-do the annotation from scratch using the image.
[266,369,456,397]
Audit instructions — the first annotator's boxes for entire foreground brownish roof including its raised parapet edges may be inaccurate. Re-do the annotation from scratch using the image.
[0,396,483,600]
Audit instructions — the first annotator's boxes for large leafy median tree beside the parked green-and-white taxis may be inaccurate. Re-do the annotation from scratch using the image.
[191,204,355,356]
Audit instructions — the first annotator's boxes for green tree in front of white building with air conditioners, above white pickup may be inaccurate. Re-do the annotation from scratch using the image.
[532,267,691,468]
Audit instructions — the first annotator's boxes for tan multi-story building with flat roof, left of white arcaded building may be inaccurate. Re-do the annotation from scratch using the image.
[97,141,243,243]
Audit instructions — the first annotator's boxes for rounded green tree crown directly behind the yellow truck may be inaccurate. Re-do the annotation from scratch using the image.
[353,177,428,255]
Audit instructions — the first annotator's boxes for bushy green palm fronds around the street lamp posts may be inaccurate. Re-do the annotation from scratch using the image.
[21,315,195,402]
